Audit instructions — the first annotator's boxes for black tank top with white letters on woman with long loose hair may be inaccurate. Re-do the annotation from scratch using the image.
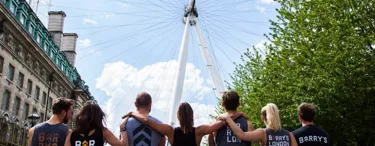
[70,129,104,146]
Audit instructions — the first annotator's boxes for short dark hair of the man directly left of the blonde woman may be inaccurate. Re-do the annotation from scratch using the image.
[222,91,240,110]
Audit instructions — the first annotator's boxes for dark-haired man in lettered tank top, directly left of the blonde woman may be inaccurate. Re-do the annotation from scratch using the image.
[208,91,253,146]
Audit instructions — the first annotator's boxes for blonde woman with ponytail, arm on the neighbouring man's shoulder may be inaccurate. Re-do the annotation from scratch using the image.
[219,103,297,146]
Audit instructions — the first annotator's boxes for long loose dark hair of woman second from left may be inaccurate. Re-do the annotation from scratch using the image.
[74,101,105,133]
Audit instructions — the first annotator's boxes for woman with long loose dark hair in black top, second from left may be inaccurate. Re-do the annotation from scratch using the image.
[65,100,128,146]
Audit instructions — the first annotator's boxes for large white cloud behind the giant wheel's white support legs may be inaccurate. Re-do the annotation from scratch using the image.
[96,60,215,137]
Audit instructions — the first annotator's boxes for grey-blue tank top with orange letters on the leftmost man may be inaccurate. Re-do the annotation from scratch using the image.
[31,122,69,146]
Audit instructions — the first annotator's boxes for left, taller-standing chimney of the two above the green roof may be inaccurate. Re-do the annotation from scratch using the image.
[48,11,66,48]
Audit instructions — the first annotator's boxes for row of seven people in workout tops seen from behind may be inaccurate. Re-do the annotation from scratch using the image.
[28,91,331,146]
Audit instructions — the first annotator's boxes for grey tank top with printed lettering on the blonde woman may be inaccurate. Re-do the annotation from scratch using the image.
[264,128,291,146]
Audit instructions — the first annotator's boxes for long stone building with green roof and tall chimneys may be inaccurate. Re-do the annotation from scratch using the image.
[0,0,95,145]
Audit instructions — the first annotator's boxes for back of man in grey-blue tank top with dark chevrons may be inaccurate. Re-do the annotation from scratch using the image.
[126,116,163,146]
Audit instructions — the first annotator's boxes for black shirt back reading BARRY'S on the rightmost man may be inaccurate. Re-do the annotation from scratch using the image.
[293,125,329,146]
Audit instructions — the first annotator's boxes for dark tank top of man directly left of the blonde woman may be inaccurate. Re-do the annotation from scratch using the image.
[216,117,251,146]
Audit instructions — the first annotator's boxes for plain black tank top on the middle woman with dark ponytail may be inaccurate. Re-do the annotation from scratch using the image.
[172,127,197,146]
